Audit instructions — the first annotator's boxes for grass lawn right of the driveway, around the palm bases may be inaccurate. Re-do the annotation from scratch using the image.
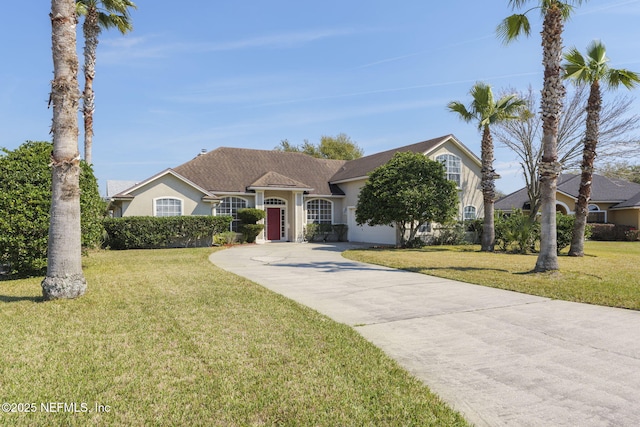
[344,241,640,310]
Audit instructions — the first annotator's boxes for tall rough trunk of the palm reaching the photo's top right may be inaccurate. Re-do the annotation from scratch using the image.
[534,3,565,272]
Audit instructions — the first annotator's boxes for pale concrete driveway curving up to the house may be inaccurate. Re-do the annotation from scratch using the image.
[210,243,640,426]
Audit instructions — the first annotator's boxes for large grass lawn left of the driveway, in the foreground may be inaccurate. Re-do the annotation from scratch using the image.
[0,249,467,426]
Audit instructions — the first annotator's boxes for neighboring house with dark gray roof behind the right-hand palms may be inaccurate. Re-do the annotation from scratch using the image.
[495,174,640,228]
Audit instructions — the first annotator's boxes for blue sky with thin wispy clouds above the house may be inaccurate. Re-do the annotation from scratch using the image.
[0,0,640,192]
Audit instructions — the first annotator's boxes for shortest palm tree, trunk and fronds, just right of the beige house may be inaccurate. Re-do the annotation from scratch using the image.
[447,83,526,252]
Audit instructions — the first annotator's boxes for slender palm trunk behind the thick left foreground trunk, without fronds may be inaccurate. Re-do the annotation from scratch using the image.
[82,4,100,164]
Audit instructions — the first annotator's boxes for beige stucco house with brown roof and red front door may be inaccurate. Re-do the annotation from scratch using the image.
[111,135,482,244]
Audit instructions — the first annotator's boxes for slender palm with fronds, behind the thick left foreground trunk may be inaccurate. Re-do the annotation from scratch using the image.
[76,0,136,164]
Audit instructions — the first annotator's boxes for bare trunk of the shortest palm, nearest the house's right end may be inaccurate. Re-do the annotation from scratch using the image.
[480,126,498,252]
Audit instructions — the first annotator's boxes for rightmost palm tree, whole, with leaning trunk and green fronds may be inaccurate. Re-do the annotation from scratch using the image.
[563,40,640,256]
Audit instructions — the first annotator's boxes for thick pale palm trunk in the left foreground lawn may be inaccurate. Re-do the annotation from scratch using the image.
[41,0,87,300]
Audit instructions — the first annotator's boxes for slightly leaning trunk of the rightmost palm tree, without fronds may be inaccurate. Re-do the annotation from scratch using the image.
[569,80,602,256]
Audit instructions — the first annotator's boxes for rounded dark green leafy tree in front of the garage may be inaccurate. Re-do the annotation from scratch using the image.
[356,152,458,246]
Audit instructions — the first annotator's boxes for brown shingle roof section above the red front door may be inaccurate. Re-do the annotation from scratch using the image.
[174,147,346,195]
